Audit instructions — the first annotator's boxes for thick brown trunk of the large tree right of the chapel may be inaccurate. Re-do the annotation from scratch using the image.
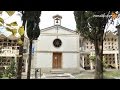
[94,38,103,79]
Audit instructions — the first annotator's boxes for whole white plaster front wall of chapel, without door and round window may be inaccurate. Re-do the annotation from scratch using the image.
[33,25,79,68]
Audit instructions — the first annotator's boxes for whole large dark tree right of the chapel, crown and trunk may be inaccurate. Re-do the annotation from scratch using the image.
[74,11,108,79]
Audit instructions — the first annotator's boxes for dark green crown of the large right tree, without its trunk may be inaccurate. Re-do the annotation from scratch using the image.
[74,11,108,42]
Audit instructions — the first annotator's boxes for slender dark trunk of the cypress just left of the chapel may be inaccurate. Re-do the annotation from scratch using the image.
[27,39,33,79]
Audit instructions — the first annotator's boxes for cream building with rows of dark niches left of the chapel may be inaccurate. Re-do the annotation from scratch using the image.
[0,34,28,72]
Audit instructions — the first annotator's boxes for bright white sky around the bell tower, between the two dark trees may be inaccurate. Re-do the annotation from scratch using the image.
[40,11,76,30]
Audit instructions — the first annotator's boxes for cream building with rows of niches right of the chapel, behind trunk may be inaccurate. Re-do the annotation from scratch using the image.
[80,31,119,69]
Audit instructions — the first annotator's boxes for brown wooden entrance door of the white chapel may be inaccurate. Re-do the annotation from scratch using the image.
[53,53,62,69]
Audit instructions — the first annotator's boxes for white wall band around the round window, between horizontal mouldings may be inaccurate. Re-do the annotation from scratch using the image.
[37,35,79,51]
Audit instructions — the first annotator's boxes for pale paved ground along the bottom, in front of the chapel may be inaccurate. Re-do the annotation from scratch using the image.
[22,70,120,79]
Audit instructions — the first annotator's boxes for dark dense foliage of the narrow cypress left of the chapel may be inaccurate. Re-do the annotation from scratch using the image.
[23,11,41,40]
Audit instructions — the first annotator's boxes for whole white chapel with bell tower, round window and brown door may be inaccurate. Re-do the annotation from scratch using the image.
[31,15,80,72]
